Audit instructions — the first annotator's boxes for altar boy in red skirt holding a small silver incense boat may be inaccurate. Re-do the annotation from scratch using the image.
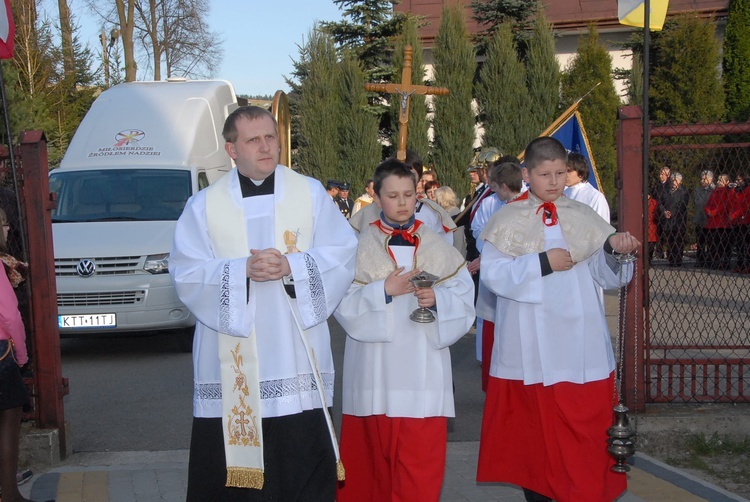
[334,159,474,502]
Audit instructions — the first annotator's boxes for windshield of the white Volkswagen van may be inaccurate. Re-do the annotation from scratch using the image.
[49,169,191,222]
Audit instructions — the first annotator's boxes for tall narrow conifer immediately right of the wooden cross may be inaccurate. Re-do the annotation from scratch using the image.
[432,6,476,193]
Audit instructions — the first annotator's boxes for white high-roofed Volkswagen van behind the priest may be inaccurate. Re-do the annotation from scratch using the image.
[50,79,237,348]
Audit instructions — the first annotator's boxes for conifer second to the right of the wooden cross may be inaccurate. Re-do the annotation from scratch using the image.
[476,23,538,155]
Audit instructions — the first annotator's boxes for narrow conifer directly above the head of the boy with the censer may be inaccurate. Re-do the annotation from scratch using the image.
[519,12,560,141]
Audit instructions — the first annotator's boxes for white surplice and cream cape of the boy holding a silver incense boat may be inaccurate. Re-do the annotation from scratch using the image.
[334,224,474,418]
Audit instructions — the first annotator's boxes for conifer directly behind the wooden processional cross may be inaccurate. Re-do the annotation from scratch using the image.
[390,16,428,158]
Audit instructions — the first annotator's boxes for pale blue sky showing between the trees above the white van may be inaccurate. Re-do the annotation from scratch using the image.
[49,0,341,96]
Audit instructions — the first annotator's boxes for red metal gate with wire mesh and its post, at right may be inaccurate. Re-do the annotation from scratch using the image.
[618,107,750,408]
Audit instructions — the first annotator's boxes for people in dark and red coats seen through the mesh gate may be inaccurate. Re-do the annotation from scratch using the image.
[648,166,750,274]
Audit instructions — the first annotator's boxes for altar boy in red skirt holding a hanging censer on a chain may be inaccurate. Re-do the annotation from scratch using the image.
[477,137,640,502]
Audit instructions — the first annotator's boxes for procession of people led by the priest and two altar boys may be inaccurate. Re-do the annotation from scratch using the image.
[164,106,640,501]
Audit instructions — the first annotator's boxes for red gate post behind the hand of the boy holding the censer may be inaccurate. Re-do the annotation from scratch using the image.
[617,106,648,412]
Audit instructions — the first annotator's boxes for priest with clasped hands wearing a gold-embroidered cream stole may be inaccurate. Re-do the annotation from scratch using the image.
[169,106,357,501]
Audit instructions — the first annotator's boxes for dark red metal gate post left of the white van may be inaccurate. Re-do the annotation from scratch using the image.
[21,131,68,458]
